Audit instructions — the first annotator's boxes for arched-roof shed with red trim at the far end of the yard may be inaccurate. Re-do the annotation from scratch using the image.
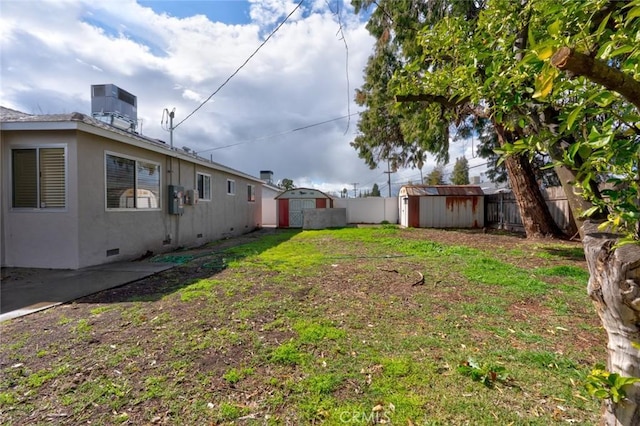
[275,188,333,228]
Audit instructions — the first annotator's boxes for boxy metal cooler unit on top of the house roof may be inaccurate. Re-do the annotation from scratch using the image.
[91,84,138,132]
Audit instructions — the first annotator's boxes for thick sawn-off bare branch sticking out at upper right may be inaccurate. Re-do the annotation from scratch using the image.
[551,46,640,110]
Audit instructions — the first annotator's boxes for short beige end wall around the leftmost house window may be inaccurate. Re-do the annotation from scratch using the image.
[2,130,80,269]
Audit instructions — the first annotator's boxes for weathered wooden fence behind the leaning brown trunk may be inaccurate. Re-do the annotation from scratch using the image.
[484,187,575,234]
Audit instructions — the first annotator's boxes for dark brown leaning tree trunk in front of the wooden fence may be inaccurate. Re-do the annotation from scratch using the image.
[494,123,562,238]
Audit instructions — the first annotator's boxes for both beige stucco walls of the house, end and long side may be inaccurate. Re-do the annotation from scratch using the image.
[1,125,262,269]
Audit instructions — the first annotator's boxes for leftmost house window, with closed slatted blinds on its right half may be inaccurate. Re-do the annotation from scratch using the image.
[11,147,67,209]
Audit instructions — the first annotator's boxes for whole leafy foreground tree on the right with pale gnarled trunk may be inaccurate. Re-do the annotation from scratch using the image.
[390,0,640,425]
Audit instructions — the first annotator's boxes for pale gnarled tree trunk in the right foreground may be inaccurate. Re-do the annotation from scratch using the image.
[583,221,640,426]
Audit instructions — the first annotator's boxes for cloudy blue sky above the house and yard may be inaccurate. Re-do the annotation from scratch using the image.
[0,0,476,193]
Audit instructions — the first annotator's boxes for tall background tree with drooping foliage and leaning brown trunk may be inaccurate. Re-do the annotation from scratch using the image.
[352,0,561,237]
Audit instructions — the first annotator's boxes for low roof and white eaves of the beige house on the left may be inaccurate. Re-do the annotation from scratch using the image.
[0,106,264,183]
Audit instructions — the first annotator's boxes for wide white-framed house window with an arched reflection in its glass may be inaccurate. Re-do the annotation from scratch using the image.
[106,154,160,209]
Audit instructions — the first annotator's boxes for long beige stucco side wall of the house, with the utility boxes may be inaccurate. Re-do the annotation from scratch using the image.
[78,133,261,266]
